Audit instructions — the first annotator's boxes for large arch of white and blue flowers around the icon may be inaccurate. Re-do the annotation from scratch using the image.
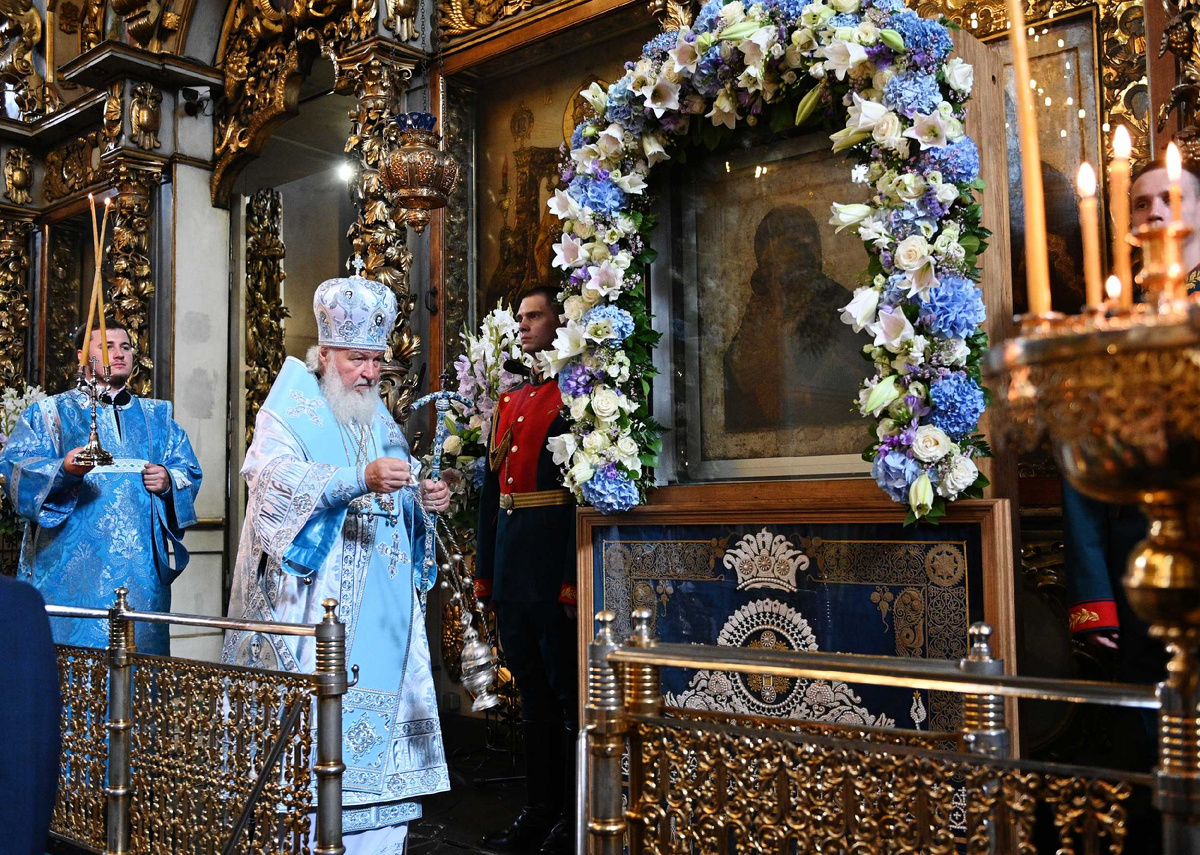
[542,0,990,520]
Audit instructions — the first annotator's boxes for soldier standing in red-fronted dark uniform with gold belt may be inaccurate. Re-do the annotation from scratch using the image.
[475,288,578,855]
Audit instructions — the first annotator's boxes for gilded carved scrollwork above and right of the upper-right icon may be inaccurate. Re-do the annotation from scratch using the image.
[917,0,1150,161]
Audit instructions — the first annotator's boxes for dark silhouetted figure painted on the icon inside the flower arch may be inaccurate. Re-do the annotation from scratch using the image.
[725,204,870,434]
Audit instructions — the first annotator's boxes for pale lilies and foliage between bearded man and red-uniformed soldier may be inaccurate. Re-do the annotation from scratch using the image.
[422,304,533,544]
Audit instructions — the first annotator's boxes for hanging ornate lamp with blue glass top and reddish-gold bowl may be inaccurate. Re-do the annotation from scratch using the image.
[383,113,458,234]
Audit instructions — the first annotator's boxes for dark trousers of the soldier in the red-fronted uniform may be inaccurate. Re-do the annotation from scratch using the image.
[496,603,578,825]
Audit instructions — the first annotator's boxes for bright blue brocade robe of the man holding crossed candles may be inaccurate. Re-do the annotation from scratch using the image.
[0,390,200,656]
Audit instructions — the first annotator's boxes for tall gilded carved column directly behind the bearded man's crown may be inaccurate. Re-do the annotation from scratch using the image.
[338,50,421,418]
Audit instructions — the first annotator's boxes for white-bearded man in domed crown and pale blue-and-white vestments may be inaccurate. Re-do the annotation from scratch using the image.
[222,268,450,855]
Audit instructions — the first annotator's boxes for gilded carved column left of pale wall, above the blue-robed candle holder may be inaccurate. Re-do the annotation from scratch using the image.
[107,161,162,395]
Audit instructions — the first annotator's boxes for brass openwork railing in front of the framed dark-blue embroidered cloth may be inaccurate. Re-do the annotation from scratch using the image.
[578,611,1176,855]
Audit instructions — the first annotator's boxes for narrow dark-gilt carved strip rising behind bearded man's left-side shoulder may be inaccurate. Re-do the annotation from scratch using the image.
[246,187,288,447]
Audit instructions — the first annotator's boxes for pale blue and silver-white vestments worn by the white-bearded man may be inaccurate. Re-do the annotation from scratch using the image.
[222,358,450,832]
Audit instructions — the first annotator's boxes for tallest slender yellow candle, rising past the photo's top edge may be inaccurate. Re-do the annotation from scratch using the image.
[1008,0,1050,315]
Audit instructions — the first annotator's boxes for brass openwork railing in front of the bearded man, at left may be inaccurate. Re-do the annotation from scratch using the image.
[46,588,356,855]
